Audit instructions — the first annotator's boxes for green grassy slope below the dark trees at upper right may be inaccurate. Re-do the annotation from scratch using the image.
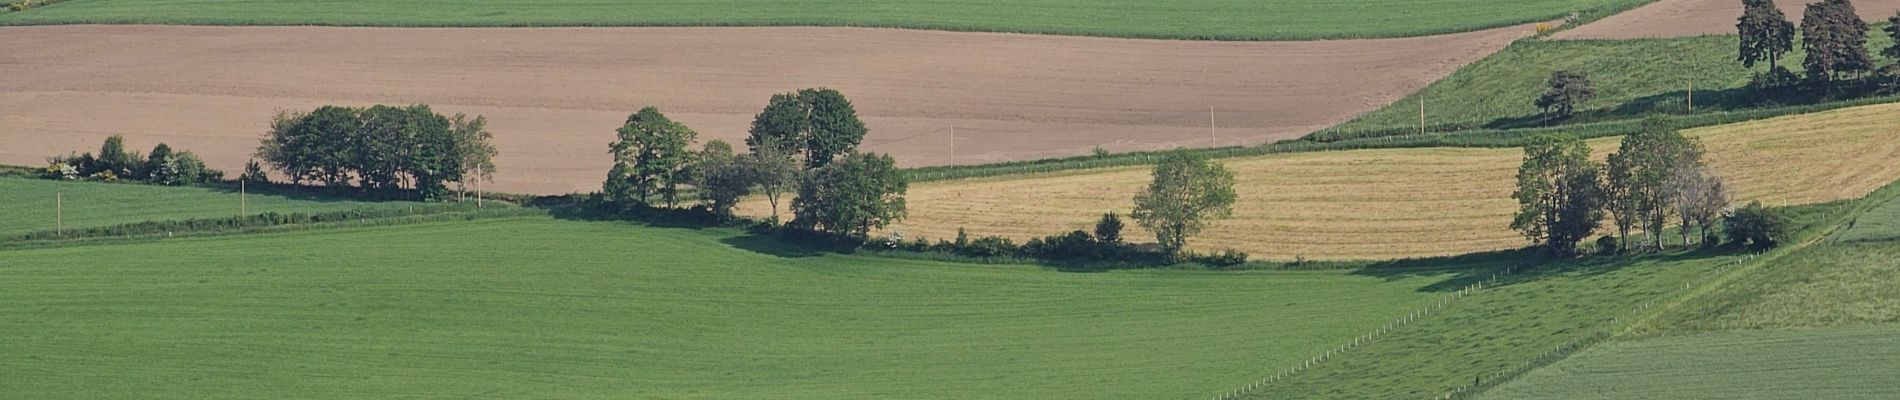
[1336,28,1892,131]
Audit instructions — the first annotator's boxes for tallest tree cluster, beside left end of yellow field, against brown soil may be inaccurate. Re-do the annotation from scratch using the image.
[602,89,908,239]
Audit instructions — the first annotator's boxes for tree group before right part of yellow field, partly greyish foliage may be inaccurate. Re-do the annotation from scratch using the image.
[1511,121,1773,256]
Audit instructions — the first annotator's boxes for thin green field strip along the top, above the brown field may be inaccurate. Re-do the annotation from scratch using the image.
[0,0,1649,40]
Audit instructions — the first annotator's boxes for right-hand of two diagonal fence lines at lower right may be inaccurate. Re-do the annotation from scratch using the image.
[1444,252,1763,400]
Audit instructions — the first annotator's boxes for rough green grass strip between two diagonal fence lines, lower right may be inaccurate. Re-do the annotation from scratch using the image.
[1245,254,1733,398]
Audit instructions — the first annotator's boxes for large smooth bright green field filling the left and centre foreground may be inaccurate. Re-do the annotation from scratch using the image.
[0,218,1482,398]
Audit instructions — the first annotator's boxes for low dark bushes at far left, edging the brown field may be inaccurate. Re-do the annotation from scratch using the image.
[46,135,224,186]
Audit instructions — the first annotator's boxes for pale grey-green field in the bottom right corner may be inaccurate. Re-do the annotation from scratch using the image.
[1484,326,1900,400]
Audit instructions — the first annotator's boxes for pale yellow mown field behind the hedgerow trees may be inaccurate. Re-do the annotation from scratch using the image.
[756,104,1900,260]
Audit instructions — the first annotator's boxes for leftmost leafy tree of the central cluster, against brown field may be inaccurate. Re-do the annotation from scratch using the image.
[606,106,697,207]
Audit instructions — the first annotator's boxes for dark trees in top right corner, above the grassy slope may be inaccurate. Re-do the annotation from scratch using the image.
[1735,0,1900,85]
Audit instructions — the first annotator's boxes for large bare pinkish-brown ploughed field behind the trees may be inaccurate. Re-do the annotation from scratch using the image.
[0,27,1531,193]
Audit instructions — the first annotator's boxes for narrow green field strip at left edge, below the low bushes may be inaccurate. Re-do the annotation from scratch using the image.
[0,178,440,235]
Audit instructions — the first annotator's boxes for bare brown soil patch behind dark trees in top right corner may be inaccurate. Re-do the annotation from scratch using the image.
[1550,0,1900,40]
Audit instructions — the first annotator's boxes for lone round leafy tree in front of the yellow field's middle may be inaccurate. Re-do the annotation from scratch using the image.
[1131,152,1235,252]
